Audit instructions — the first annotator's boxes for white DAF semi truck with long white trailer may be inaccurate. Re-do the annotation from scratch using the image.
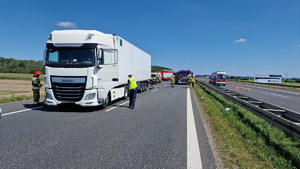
[44,30,151,108]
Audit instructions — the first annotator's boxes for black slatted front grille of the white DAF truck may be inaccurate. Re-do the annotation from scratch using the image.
[52,76,85,102]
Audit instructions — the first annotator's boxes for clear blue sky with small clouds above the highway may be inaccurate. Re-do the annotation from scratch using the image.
[0,0,300,78]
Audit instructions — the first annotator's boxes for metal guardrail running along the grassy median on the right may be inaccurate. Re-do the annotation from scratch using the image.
[197,80,300,139]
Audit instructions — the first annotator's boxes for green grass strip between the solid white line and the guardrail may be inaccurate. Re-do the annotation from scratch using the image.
[194,83,300,168]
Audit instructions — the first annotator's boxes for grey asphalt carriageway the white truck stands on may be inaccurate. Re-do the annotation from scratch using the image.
[0,82,216,168]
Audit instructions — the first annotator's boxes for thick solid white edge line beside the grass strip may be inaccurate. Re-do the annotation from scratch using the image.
[187,88,202,169]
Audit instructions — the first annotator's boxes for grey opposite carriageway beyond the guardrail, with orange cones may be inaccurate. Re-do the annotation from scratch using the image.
[198,78,300,113]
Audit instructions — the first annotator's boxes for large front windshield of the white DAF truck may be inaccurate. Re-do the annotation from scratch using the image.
[46,48,95,67]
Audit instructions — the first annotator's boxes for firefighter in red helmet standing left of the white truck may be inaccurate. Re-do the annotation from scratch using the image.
[31,71,43,106]
